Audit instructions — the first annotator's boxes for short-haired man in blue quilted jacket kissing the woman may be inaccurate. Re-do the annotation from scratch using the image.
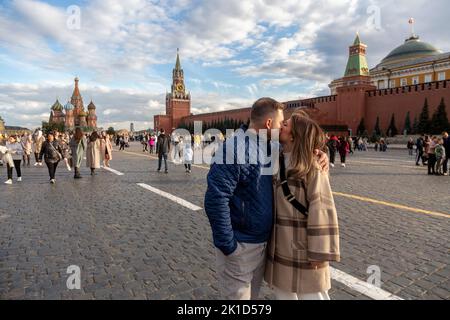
[205,98,328,300]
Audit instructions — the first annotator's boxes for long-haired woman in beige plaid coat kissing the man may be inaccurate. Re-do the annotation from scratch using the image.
[265,113,340,300]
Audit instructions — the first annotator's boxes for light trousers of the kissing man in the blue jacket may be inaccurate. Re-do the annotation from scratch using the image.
[216,243,266,300]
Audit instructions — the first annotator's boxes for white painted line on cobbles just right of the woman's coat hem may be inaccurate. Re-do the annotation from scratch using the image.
[330,267,403,300]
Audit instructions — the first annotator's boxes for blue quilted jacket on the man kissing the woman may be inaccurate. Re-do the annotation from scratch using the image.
[205,127,273,255]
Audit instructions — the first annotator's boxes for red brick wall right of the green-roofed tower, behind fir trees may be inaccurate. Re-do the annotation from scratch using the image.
[366,80,450,133]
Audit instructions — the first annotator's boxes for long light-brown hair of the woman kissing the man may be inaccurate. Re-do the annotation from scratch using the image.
[288,112,325,181]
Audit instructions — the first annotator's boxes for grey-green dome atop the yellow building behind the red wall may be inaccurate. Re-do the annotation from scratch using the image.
[380,36,442,66]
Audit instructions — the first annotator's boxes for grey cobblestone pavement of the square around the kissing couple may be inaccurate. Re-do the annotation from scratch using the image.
[0,144,450,299]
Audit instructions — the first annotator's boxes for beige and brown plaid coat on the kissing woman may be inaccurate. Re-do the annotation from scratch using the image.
[265,164,340,294]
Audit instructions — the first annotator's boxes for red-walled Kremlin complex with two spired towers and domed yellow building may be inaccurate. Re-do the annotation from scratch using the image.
[154,21,450,135]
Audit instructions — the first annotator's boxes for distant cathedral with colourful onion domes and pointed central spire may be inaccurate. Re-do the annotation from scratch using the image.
[49,78,97,131]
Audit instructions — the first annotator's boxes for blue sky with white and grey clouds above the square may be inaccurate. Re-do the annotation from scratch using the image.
[0,0,450,130]
